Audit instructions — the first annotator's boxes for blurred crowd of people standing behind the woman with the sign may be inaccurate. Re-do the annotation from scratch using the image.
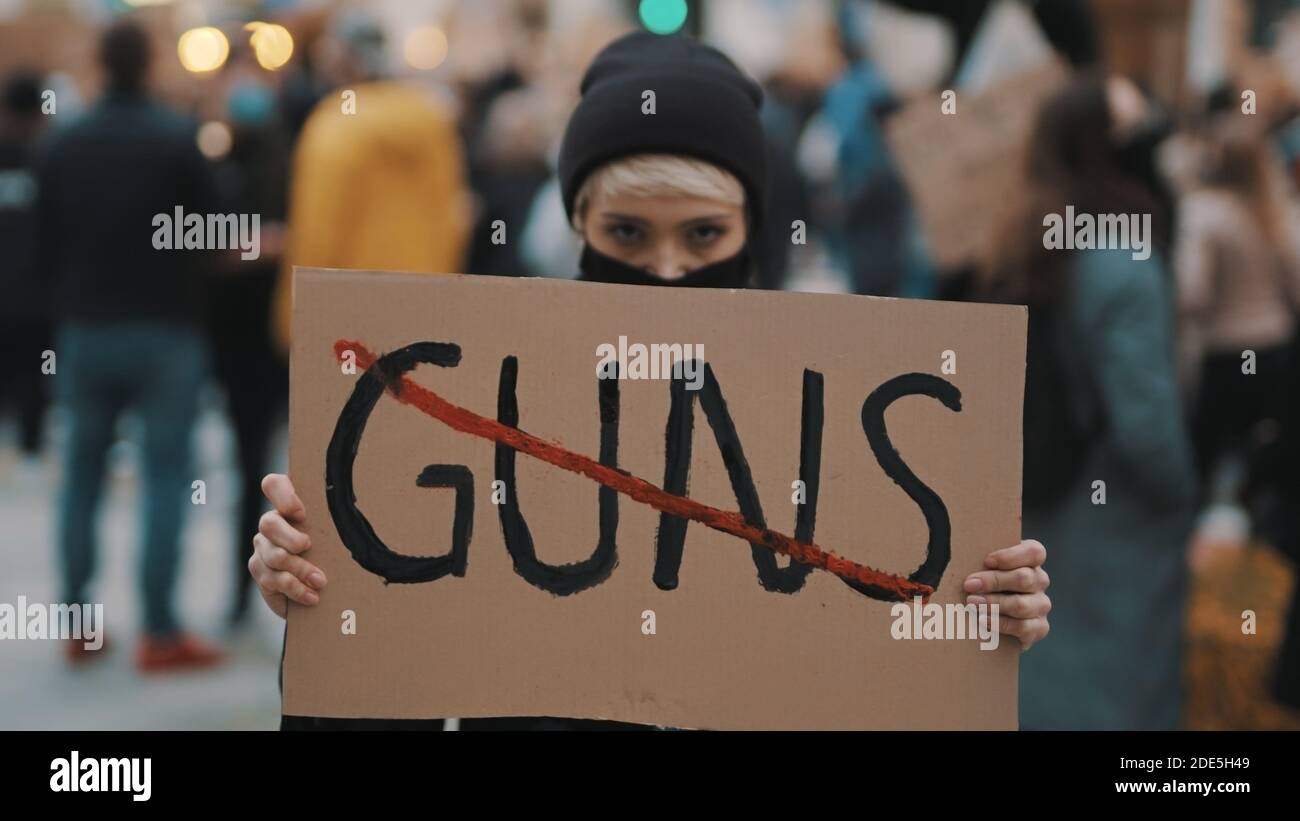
[0,0,1300,729]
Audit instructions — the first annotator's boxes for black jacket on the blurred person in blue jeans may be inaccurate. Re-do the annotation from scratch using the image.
[36,91,220,323]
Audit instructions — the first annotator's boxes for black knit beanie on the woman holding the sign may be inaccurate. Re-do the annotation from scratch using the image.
[559,31,767,226]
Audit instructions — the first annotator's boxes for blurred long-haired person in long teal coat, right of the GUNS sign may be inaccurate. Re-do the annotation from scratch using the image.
[982,74,1195,730]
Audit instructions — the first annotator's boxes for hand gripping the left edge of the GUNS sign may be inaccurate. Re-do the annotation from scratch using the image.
[248,473,325,618]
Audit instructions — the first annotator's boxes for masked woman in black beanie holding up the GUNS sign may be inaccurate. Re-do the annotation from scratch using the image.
[248,32,1050,730]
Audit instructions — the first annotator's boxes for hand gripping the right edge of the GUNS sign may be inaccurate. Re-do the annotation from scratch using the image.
[965,539,1052,652]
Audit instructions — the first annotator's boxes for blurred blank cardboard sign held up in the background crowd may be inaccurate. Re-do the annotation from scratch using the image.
[885,61,1069,268]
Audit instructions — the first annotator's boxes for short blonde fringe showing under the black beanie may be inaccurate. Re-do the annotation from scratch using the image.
[573,153,745,230]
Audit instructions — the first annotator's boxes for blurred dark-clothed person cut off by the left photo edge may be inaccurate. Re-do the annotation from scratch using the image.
[0,71,51,456]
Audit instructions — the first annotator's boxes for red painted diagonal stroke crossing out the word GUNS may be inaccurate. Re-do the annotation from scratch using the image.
[334,339,935,601]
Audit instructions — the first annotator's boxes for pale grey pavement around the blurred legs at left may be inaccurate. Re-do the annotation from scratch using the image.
[0,392,283,730]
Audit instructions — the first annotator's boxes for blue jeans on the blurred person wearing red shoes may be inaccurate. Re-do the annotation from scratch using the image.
[55,321,208,637]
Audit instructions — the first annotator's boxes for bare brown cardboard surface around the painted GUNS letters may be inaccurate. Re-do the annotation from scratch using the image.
[283,269,1026,729]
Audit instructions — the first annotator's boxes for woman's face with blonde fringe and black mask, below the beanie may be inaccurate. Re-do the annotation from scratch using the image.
[575,155,750,288]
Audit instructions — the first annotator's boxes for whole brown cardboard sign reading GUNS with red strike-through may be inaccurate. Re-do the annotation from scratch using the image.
[283,269,1026,729]
